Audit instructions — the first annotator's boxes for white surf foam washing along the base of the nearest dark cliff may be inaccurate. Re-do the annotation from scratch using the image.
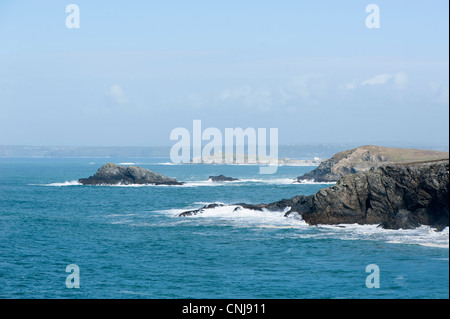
[165,203,449,249]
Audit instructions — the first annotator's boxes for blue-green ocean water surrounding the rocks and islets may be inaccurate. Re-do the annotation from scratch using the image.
[0,158,449,299]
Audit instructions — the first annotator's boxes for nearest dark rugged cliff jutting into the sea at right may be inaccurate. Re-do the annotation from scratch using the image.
[178,160,449,230]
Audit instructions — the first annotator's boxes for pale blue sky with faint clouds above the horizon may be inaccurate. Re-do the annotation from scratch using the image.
[0,0,449,146]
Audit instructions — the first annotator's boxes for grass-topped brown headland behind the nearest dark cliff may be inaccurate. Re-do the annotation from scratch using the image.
[297,145,449,182]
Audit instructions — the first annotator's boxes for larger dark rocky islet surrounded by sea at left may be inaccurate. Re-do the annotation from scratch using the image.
[79,163,183,185]
